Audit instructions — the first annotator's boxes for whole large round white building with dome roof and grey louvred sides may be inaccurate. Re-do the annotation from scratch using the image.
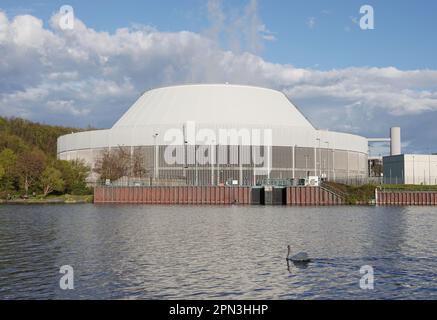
[58,84,369,185]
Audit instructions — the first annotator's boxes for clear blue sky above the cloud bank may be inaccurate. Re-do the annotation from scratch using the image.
[1,0,437,70]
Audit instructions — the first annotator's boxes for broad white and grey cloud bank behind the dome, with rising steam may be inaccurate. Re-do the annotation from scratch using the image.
[0,8,437,151]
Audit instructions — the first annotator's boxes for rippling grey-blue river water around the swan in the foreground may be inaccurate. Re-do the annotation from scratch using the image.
[0,204,437,299]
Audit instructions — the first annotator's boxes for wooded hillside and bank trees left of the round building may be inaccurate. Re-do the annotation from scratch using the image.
[0,117,90,199]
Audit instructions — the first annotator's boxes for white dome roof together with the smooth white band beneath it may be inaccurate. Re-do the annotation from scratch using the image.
[58,84,368,154]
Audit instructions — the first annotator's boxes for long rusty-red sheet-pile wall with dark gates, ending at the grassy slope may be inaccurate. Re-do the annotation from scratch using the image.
[94,186,345,206]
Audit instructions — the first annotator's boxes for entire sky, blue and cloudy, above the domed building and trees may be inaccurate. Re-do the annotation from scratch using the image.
[0,0,437,155]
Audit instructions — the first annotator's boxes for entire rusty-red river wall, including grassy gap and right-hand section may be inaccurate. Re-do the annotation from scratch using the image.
[94,183,437,206]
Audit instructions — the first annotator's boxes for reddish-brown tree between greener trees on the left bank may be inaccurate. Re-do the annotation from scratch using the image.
[15,149,46,196]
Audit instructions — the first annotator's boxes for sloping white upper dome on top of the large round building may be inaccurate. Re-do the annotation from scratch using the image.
[113,84,314,130]
